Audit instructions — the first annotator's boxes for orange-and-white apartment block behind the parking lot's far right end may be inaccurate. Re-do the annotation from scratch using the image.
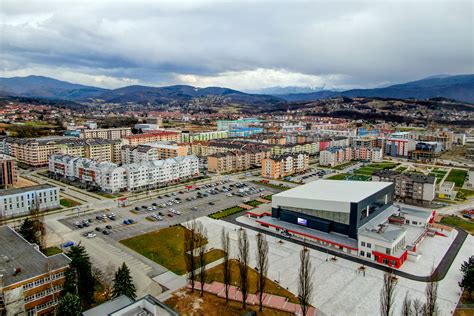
[261,153,309,179]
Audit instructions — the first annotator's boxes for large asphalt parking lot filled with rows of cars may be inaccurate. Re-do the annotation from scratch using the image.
[60,180,277,240]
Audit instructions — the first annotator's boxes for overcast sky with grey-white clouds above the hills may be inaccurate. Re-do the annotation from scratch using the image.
[0,0,474,90]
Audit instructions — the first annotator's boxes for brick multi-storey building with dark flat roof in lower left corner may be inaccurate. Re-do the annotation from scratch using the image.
[0,225,70,315]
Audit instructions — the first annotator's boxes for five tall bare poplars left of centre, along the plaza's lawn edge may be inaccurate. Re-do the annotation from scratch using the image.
[184,220,314,315]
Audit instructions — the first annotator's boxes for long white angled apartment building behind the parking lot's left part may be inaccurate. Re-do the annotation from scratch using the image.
[49,155,199,193]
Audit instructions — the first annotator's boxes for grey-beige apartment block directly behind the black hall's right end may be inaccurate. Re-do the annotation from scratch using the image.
[372,170,436,205]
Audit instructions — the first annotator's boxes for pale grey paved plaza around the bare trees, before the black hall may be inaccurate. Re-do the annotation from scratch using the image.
[191,217,474,315]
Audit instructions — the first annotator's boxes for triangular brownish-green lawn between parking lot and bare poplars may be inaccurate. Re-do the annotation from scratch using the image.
[120,226,224,275]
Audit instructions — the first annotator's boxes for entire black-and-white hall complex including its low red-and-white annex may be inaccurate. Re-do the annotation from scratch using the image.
[249,180,442,268]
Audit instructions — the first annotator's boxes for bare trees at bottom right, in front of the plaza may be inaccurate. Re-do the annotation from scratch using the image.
[380,272,438,316]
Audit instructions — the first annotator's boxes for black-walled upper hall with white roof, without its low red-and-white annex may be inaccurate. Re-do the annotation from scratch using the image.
[272,180,395,239]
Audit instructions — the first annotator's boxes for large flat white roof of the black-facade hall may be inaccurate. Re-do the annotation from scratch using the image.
[273,180,392,202]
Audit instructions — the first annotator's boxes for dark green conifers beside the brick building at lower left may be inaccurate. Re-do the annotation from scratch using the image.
[57,245,136,316]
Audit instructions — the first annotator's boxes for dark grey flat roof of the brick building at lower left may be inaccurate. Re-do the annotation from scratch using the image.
[0,226,70,286]
